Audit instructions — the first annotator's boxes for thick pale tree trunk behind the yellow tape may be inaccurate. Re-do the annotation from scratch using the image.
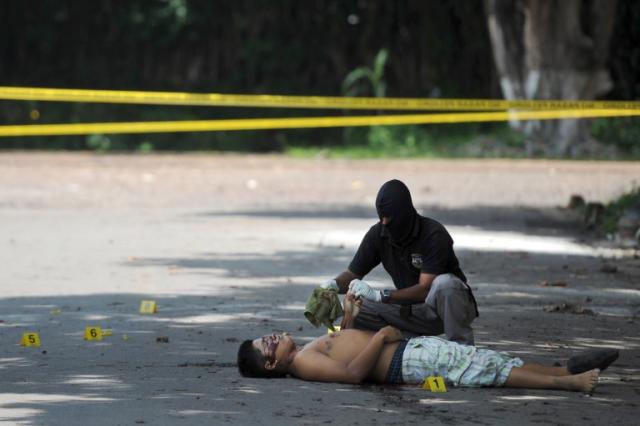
[485,0,616,156]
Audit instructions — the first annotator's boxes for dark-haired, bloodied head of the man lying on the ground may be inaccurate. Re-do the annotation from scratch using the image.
[238,333,297,378]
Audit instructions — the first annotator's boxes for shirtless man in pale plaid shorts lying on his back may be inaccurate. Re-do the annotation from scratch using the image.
[238,294,618,393]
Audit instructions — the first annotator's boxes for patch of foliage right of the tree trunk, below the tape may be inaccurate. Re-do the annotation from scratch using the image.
[591,117,640,155]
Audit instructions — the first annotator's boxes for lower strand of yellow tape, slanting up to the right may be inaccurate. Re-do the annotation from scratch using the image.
[0,109,640,137]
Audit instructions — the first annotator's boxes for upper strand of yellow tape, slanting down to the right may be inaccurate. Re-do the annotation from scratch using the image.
[0,86,640,111]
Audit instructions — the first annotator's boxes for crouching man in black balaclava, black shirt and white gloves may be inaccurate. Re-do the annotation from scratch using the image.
[321,179,478,345]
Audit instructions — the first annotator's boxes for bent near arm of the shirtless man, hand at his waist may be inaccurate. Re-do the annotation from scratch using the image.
[290,326,402,384]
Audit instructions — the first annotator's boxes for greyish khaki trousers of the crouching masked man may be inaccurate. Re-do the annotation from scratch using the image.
[353,274,477,345]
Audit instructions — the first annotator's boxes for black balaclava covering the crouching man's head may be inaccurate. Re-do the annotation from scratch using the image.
[376,179,418,244]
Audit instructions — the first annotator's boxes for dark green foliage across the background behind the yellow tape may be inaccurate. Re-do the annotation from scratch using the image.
[0,0,640,156]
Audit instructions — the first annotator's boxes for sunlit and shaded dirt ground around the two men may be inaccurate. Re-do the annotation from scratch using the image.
[0,153,640,425]
